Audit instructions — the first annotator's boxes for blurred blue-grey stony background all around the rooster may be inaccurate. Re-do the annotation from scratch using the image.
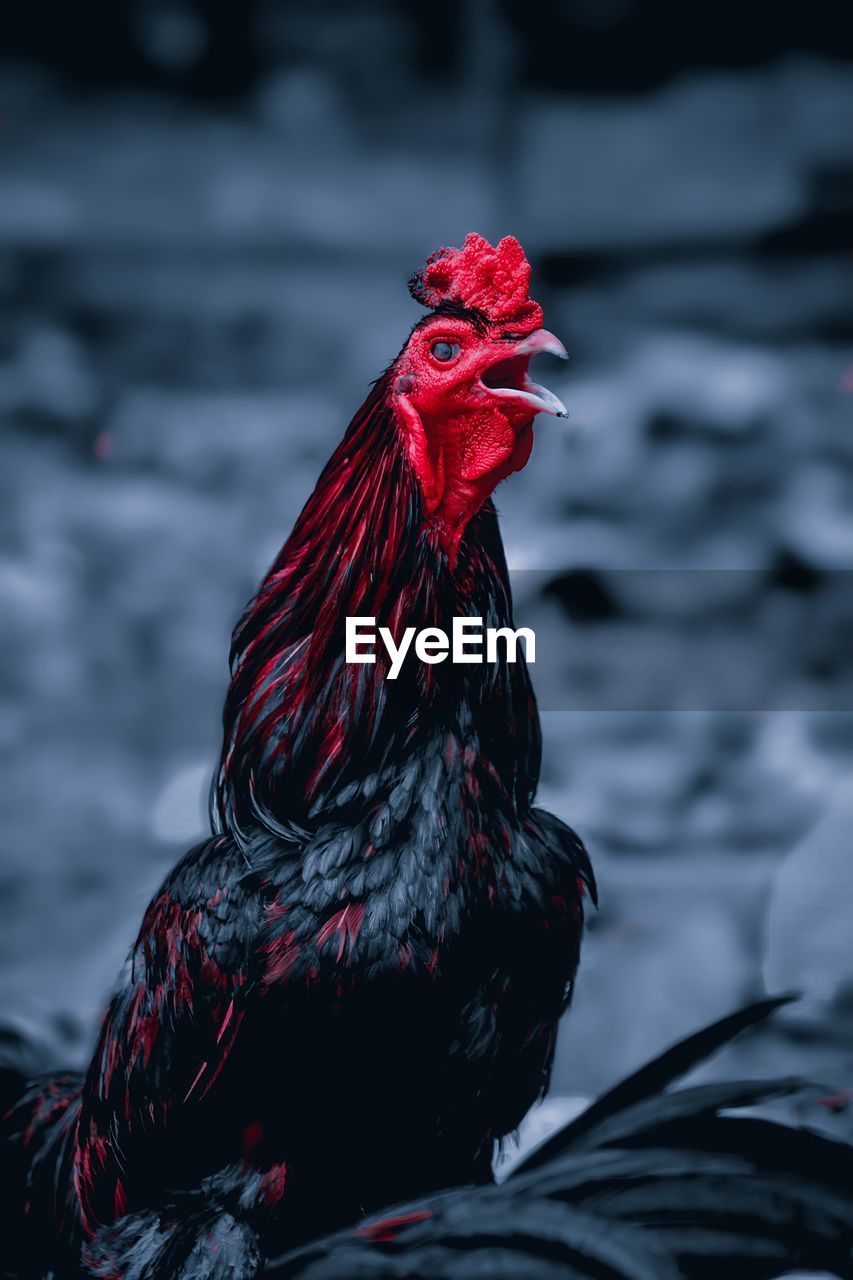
[0,0,853,1131]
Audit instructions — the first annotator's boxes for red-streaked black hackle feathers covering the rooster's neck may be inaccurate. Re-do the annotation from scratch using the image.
[211,375,538,835]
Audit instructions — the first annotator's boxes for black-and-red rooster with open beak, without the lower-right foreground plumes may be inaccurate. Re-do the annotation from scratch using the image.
[3,234,596,1280]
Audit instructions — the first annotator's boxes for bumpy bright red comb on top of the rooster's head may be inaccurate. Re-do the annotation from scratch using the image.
[409,233,542,328]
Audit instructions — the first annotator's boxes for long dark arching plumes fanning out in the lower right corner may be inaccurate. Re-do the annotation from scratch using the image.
[266,1000,853,1280]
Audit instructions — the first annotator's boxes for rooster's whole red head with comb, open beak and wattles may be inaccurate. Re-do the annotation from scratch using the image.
[392,236,566,553]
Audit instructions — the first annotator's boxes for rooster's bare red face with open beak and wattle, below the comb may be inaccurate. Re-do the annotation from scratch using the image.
[392,314,565,561]
